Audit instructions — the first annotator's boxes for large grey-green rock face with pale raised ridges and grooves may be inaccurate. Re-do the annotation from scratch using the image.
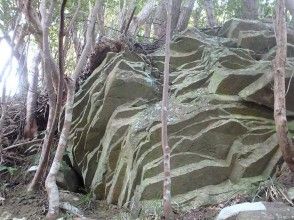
[69,20,294,211]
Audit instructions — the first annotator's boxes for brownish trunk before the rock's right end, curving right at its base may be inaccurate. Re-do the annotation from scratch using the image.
[273,0,294,172]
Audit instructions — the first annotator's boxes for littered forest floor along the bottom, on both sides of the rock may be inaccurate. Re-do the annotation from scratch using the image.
[0,160,294,220]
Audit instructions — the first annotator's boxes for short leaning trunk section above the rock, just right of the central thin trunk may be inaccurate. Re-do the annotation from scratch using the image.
[177,0,196,32]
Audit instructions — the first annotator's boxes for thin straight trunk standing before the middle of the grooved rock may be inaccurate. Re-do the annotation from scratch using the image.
[161,1,172,220]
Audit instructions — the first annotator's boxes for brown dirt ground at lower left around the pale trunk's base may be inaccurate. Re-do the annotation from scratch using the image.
[0,185,125,220]
